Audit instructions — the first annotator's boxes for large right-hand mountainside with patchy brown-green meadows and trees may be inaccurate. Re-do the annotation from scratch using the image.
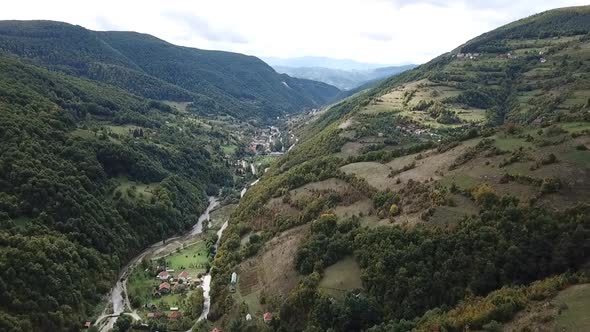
[211,6,590,331]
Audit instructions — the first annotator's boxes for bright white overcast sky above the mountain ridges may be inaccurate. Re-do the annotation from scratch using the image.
[0,0,587,65]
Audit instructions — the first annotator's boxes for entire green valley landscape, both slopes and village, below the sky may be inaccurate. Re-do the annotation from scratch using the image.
[0,2,590,332]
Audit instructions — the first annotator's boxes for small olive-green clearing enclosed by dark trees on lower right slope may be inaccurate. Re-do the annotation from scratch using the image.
[319,257,363,298]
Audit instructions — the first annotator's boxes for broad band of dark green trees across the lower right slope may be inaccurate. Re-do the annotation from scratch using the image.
[280,197,590,331]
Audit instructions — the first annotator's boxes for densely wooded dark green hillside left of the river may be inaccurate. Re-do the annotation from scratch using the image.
[0,55,237,331]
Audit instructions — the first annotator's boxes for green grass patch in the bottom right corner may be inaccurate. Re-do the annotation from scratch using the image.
[553,284,590,331]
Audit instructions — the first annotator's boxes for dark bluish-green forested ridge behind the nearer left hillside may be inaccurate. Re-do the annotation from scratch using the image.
[0,21,339,120]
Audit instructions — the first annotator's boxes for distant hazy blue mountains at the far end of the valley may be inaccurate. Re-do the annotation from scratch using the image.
[273,65,415,90]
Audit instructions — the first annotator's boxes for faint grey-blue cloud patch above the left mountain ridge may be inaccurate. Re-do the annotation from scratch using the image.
[164,11,248,44]
